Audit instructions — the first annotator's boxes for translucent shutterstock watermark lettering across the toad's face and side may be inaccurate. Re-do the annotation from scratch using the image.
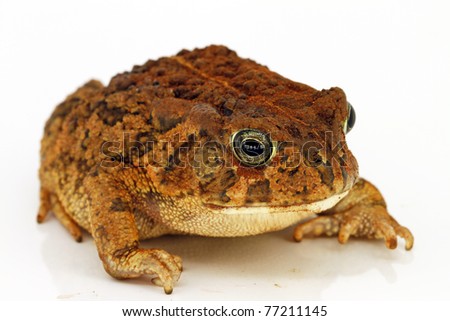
[100,131,347,169]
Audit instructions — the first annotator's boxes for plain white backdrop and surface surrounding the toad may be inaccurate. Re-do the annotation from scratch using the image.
[0,0,450,300]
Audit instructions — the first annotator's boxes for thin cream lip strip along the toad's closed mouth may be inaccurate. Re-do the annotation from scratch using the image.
[205,191,349,215]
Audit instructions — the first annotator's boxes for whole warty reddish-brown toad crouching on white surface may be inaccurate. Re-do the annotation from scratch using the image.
[37,45,414,294]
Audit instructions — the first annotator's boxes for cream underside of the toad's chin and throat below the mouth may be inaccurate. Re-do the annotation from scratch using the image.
[170,191,348,237]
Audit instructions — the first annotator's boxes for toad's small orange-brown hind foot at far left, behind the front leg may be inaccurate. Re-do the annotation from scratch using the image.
[37,188,83,242]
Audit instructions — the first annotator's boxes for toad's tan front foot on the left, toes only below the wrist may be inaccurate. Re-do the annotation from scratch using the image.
[102,248,183,294]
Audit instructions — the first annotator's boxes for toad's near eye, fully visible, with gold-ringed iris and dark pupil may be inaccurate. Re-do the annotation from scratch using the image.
[231,129,276,166]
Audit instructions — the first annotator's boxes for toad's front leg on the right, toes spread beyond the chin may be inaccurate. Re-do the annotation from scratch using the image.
[294,178,414,250]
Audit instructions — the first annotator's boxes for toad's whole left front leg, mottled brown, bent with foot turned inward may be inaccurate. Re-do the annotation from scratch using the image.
[87,170,182,294]
